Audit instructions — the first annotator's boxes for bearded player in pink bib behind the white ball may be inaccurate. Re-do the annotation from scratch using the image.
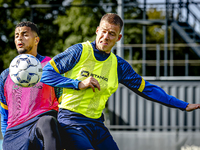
[0,21,61,150]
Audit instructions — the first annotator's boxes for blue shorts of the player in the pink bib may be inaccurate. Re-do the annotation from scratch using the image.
[3,111,55,150]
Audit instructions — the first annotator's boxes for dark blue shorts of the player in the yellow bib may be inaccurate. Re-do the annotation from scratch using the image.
[58,109,119,150]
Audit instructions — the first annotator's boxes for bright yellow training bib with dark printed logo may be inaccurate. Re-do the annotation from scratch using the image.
[59,41,118,119]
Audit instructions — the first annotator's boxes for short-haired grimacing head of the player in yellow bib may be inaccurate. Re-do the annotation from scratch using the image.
[96,13,123,53]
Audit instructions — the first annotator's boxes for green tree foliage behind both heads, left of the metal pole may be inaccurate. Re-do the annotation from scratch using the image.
[0,0,141,71]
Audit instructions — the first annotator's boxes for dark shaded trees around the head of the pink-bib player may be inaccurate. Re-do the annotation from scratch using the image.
[0,0,65,72]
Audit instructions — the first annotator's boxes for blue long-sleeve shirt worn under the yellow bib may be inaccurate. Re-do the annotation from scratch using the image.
[41,41,188,110]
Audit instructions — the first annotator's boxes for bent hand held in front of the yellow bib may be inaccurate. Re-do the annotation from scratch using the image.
[78,76,101,92]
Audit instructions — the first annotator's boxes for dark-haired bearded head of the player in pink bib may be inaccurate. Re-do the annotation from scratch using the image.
[15,21,40,56]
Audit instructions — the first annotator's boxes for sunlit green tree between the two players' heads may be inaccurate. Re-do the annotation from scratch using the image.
[53,0,119,49]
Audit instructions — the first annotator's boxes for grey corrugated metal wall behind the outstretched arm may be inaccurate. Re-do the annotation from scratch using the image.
[106,77,200,132]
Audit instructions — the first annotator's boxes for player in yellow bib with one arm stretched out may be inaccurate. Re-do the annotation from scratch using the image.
[41,13,200,150]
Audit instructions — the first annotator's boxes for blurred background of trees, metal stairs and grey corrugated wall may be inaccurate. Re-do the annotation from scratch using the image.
[0,0,200,150]
